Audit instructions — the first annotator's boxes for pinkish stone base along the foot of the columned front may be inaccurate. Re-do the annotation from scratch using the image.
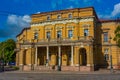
[21,65,94,71]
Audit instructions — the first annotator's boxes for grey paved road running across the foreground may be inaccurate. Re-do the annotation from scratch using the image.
[0,72,120,80]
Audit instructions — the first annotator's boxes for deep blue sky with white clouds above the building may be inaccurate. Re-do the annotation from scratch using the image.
[0,0,120,42]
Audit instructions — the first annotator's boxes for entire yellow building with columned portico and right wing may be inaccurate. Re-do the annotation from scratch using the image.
[16,7,120,71]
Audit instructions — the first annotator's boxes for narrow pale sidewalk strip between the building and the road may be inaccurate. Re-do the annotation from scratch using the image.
[4,70,120,74]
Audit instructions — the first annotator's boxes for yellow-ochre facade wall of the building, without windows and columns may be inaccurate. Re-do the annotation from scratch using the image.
[16,7,120,70]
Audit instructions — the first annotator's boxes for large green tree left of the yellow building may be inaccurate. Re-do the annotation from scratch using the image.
[0,39,16,63]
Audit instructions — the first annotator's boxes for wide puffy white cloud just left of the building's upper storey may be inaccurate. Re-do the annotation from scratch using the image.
[7,15,31,27]
